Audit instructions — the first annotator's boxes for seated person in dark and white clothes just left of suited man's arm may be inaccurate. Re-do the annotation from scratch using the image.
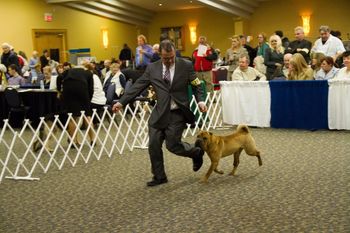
[103,62,126,104]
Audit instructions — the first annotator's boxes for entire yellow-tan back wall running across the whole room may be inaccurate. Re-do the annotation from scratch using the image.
[0,0,350,60]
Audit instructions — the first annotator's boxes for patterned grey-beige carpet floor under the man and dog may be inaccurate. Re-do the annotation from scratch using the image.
[0,128,350,233]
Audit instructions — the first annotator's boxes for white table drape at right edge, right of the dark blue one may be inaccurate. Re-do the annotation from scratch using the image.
[328,80,350,130]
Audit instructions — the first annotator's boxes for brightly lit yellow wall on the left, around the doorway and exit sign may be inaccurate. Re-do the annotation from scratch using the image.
[0,0,142,60]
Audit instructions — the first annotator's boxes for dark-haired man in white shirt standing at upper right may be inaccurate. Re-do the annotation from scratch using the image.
[311,26,345,61]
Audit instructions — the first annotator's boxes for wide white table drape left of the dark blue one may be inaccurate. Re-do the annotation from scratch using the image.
[220,81,271,127]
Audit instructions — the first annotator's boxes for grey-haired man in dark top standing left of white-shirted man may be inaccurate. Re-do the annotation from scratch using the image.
[287,26,312,64]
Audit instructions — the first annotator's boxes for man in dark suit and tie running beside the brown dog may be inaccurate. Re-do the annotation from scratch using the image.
[113,40,207,186]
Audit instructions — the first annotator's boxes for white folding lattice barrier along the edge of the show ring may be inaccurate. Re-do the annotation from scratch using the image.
[0,91,223,183]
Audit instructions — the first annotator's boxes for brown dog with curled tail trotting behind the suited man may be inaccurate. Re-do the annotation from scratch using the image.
[196,125,262,182]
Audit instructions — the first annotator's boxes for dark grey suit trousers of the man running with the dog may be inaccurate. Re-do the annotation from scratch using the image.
[148,109,199,179]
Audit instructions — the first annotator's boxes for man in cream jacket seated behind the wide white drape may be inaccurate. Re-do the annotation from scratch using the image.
[232,54,266,81]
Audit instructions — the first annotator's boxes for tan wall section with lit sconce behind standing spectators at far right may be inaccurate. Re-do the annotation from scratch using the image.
[248,0,350,46]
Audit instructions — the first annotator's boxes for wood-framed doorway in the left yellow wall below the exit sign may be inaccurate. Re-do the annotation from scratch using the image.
[32,29,68,63]
